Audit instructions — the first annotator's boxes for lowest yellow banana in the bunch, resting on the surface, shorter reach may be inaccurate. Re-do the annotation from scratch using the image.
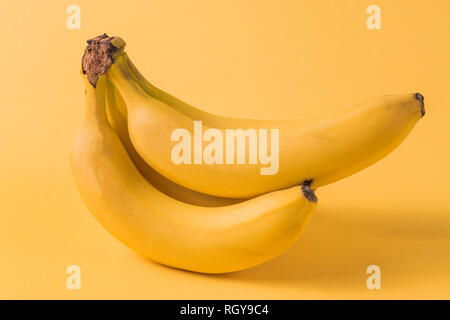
[71,76,317,273]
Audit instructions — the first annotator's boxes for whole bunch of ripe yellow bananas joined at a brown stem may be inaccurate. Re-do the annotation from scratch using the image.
[72,34,425,273]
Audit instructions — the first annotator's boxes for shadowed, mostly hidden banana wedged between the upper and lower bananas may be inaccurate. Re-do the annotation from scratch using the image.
[106,80,243,207]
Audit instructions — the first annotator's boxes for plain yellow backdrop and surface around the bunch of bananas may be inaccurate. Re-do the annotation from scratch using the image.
[0,0,450,299]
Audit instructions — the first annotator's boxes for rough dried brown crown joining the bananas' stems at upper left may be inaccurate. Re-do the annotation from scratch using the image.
[81,33,125,88]
